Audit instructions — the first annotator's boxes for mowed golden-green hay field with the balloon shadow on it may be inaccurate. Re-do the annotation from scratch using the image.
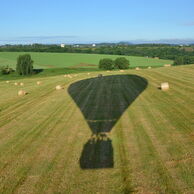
[0,65,194,194]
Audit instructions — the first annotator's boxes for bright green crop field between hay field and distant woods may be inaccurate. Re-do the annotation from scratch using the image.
[0,52,173,69]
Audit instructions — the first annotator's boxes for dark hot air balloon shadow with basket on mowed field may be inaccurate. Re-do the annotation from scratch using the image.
[68,75,148,169]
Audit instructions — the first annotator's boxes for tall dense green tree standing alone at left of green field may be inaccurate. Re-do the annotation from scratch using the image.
[16,54,33,75]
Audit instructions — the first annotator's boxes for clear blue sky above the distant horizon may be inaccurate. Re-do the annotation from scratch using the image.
[0,0,194,43]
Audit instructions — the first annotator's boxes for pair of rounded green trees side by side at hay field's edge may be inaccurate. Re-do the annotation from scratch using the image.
[99,57,130,70]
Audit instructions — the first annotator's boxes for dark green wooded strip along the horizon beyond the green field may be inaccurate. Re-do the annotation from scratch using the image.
[0,44,194,63]
